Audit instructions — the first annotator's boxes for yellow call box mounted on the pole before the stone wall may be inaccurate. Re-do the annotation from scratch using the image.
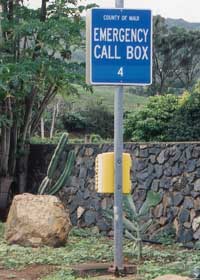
[95,152,132,194]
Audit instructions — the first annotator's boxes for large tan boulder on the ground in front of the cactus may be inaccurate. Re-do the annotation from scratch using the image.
[5,194,71,247]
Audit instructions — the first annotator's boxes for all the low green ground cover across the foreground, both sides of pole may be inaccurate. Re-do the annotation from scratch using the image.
[0,224,200,280]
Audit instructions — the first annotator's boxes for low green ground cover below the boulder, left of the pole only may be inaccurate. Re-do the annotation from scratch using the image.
[0,229,112,268]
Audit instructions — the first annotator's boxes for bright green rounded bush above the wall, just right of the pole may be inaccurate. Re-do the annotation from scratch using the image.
[124,94,178,141]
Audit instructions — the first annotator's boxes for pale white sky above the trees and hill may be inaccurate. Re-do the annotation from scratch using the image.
[26,0,200,22]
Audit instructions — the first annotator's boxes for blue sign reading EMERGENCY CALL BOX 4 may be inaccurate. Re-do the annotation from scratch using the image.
[89,8,152,85]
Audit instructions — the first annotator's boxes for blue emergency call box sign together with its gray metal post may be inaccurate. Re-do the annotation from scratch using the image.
[86,4,152,272]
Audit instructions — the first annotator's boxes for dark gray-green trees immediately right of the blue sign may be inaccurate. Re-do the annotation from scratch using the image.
[150,16,200,95]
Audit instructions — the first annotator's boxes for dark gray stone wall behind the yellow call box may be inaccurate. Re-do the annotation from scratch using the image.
[29,143,200,243]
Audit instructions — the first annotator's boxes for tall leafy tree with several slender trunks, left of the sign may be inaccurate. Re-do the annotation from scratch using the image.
[0,0,88,206]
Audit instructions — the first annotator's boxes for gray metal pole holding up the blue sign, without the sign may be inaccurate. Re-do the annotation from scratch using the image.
[114,0,124,270]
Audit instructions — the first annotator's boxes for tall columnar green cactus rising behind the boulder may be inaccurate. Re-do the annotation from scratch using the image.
[38,133,75,195]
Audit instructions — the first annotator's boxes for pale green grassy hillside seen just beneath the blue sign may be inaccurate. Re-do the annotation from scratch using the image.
[67,86,148,111]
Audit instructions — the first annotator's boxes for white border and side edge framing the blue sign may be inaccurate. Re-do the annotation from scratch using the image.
[86,8,153,86]
